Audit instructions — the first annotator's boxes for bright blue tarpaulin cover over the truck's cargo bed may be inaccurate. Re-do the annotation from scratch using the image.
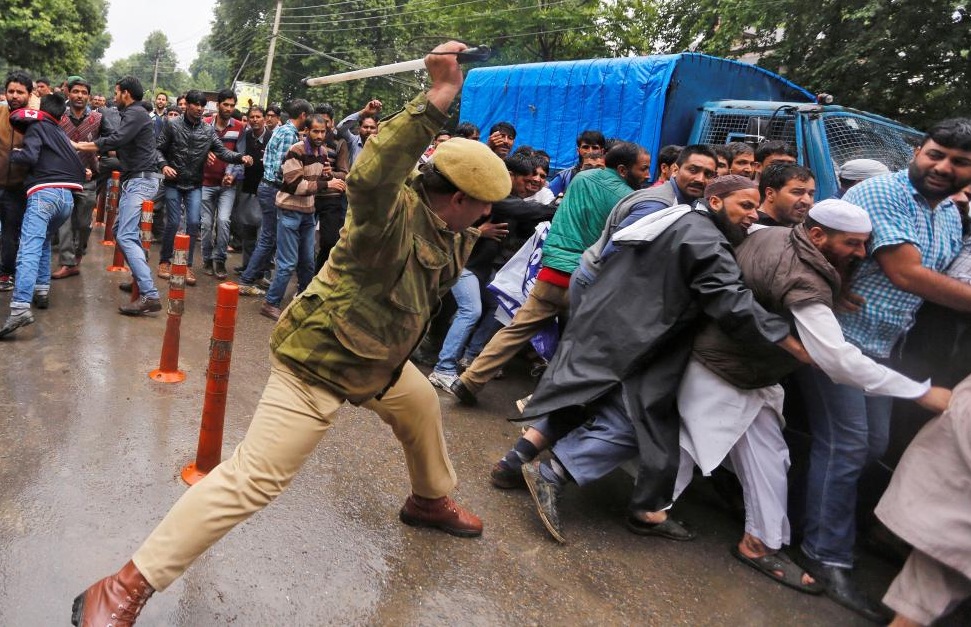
[460,53,814,171]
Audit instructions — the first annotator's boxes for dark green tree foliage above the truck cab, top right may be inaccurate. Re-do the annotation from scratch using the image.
[636,0,971,127]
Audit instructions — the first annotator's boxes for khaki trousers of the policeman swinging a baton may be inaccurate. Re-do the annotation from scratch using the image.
[132,357,456,590]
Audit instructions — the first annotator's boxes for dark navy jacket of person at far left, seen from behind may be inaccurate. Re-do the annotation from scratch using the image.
[10,112,84,191]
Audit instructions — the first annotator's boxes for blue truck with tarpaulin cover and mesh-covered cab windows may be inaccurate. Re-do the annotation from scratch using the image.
[460,53,922,199]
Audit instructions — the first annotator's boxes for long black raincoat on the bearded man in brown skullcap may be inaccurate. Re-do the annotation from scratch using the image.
[523,211,789,511]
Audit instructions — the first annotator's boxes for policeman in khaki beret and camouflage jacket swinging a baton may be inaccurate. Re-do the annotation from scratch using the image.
[72,42,510,625]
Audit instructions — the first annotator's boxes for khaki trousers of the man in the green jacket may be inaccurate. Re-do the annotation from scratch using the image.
[460,281,570,394]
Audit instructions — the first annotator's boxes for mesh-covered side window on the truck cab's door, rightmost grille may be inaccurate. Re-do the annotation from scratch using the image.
[823,113,921,172]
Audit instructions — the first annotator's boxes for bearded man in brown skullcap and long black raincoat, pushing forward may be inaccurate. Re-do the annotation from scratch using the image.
[522,176,808,542]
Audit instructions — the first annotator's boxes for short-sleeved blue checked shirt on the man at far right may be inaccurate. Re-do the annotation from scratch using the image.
[837,170,962,357]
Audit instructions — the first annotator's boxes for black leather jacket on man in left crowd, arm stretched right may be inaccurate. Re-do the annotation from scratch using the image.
[156,114,243,189]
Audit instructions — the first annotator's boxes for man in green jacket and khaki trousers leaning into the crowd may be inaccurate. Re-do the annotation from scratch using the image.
[449,142,651,405]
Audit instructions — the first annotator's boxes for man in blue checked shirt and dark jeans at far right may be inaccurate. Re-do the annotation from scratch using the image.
[799,118,971,621]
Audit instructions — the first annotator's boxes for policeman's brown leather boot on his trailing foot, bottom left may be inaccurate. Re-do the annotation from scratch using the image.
[71,561,155,627]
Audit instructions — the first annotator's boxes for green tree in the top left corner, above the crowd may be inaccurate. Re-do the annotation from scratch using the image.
[0,0,111,76]
